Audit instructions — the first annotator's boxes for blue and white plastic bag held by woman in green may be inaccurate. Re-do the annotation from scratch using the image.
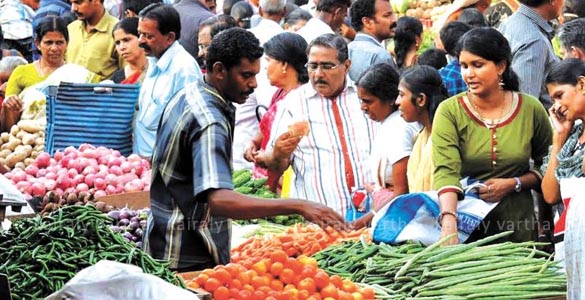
[372,192,497,245]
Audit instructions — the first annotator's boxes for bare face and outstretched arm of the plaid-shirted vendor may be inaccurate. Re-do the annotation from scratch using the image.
[205,54,346,229]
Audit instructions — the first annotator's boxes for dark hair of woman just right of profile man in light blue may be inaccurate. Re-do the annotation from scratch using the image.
[394,17,423,68]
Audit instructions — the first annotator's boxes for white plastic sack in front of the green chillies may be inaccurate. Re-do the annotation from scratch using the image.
[45,260,199,300]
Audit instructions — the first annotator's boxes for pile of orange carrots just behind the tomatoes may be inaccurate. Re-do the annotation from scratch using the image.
[231,224,369,267]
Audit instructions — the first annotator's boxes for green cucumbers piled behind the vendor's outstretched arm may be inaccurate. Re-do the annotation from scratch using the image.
[232,169,305,226]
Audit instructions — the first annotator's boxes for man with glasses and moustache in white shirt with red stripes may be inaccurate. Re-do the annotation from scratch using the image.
[266,34,376,215]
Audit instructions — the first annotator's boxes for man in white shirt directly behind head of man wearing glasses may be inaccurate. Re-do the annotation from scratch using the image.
[297,0,351,44]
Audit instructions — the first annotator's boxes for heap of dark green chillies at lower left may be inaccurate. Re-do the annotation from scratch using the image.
[0,206,184,299]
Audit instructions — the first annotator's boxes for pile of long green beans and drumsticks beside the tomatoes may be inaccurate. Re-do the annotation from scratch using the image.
[313,232,566,299]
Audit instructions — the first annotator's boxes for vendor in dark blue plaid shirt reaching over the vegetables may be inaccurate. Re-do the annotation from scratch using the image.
[144,28,344,272]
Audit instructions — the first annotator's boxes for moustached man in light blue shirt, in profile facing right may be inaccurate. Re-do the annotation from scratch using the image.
[347,0,396,81]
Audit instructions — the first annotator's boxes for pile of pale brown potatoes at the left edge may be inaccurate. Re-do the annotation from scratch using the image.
[0,120,45,170]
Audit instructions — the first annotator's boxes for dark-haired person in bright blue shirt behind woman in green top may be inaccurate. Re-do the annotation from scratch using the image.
[439,21,471,97]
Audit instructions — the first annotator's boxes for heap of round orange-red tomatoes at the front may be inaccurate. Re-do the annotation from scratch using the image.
[187,250,374,300]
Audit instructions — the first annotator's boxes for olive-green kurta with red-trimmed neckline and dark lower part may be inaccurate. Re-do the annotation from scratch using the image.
[431,93,552,242]
